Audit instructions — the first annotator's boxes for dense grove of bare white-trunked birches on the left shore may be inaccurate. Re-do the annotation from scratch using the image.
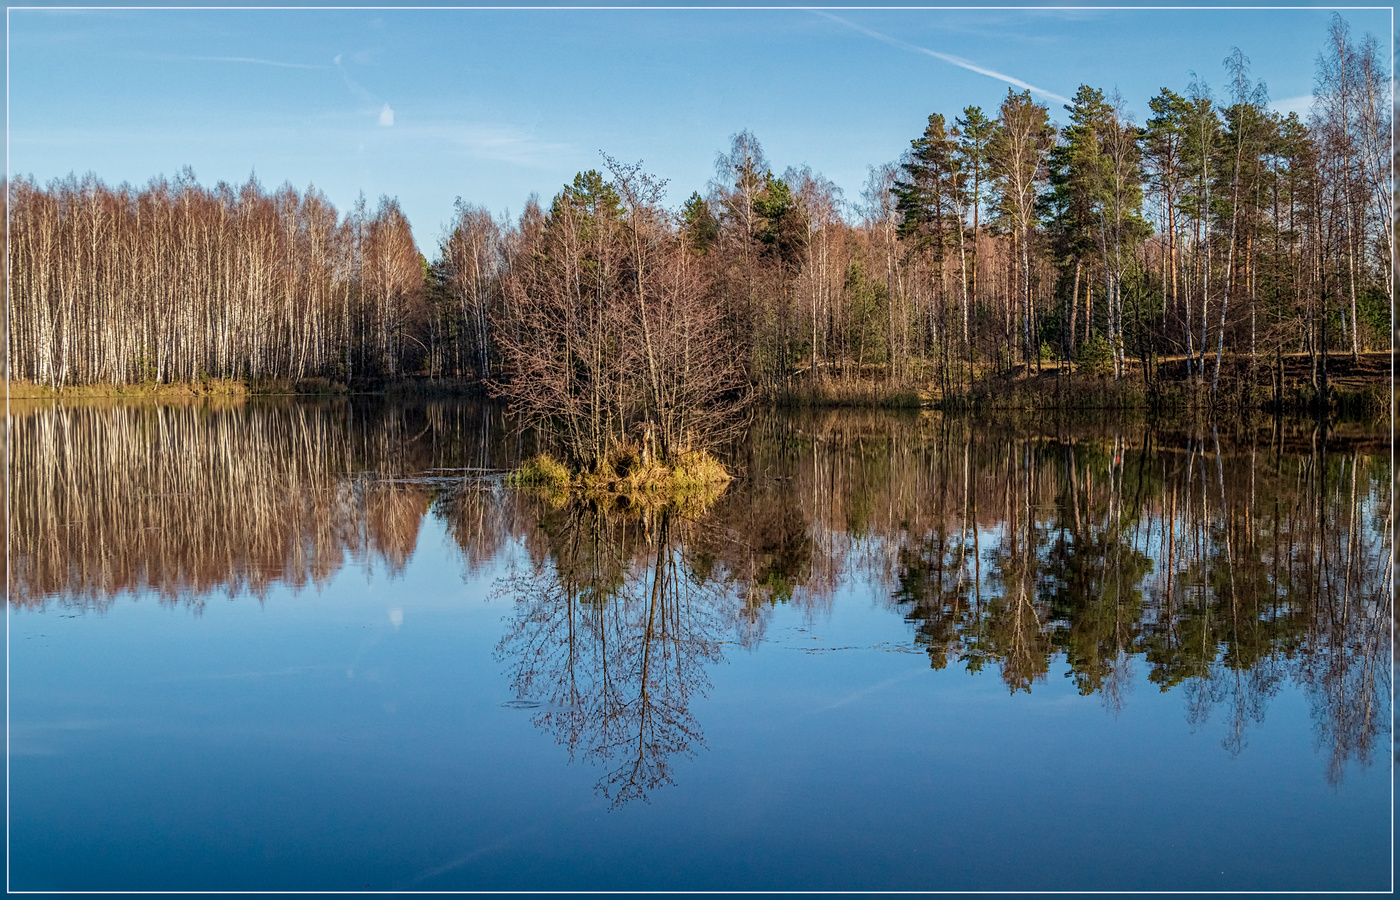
[8,168,423,386]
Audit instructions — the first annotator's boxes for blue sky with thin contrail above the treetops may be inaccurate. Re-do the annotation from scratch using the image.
[8,8,1392,247]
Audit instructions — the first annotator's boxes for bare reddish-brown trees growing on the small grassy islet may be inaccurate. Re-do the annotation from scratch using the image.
[496,160,743,469]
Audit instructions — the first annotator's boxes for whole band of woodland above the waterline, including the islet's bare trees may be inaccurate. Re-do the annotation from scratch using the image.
[7,17,1394,433]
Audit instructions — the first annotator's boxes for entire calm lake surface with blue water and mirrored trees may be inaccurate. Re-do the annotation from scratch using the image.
[8,402,1393,890]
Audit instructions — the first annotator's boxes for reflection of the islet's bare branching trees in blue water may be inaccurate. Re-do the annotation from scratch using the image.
[497,501,739,806]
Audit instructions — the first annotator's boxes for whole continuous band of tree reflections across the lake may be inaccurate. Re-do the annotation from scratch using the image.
[8,400,1394,803]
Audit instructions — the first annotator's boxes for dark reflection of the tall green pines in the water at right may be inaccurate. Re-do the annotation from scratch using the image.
[862,426,1393,780]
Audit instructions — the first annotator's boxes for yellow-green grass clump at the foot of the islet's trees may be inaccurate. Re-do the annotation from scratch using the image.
[505,445,731,511]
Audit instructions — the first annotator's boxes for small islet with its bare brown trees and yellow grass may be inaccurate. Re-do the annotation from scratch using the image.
[491,155,749,505]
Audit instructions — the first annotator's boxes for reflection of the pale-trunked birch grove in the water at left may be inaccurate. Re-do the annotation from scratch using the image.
[8,400,526,607]
